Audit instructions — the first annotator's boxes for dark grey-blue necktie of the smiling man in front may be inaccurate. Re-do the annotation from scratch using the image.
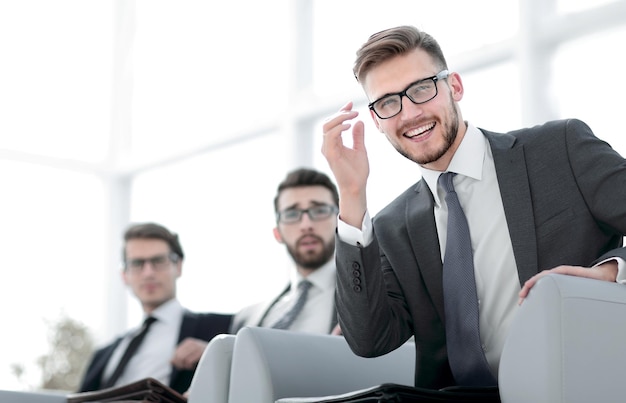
[439,172,496,386]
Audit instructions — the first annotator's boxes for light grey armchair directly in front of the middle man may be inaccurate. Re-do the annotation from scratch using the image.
[225,327,415,403]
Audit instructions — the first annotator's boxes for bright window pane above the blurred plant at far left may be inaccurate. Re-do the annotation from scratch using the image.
[0,159,109,389]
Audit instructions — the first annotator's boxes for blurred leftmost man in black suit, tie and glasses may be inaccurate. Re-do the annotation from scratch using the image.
[79,223,232,393]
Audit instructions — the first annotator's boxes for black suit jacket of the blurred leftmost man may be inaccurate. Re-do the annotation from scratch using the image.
[79,311,232,393]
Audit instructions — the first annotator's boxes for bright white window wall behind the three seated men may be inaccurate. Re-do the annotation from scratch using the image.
[0,0,626,389]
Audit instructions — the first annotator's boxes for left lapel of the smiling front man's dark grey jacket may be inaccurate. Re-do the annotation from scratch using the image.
[406,179,444,319]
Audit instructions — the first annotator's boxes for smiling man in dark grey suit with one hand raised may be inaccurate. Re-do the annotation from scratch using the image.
[323,26,626,388]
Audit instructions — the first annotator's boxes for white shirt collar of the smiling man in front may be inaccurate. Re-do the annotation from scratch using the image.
[420,123,485,205]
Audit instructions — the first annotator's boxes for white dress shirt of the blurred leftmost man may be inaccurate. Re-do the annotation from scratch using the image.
[103,299,185,386]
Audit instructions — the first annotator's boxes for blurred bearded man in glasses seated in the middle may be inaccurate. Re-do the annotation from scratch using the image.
[231,168,339,334]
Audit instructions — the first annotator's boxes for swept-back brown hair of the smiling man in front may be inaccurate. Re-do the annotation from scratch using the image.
[352,25,448,82]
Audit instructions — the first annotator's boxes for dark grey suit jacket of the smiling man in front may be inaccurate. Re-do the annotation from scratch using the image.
[336,120,626,388]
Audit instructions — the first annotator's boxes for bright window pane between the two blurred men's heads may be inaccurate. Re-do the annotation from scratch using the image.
[128,133,289,324]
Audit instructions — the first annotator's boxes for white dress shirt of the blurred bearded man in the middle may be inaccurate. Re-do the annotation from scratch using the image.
[261,259,336,334]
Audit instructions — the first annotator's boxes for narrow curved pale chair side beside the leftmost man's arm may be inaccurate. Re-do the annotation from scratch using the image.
[188,334,235,403]
